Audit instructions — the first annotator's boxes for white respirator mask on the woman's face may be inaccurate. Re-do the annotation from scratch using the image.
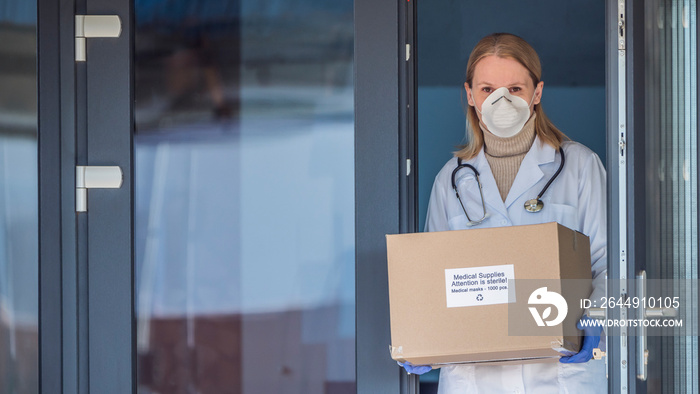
[474,87,537,138]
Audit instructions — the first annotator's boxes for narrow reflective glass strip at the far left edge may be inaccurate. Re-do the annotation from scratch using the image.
[0,0,39,394]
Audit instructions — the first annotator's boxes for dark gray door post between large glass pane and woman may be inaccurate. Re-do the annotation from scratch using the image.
[354,0,418,394]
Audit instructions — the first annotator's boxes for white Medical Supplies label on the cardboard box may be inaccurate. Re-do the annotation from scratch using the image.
[445,264,515,308]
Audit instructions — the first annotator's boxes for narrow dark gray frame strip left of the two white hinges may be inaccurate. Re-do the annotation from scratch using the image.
[37,0,78,393]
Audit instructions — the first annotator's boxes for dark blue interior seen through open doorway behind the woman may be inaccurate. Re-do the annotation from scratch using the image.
[416,0,607,393]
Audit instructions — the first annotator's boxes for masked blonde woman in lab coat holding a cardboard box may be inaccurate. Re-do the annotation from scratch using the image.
[405,33,607,393]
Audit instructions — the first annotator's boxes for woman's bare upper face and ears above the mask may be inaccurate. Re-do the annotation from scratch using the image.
[464,55,544,120]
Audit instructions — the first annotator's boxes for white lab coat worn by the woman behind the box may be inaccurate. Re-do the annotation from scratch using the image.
[425,138,607,394]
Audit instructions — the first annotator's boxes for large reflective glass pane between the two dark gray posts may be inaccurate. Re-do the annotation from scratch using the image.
[134,0,355,393]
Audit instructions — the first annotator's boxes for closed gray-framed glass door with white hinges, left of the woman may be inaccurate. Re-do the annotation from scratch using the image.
[35,0,406,393]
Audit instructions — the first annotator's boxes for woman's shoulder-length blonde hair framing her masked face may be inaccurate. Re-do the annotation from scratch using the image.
[455,33,569,160]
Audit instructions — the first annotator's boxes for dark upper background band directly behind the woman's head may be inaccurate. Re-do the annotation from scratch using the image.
[417,0,605,86]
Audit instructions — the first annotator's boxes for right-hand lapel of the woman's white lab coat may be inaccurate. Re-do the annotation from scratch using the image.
[505,136,556,208]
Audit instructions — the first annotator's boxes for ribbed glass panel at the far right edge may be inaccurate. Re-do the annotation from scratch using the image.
[645,0,700,393]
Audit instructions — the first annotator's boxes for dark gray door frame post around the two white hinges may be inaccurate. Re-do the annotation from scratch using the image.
[37,0,136,393]
